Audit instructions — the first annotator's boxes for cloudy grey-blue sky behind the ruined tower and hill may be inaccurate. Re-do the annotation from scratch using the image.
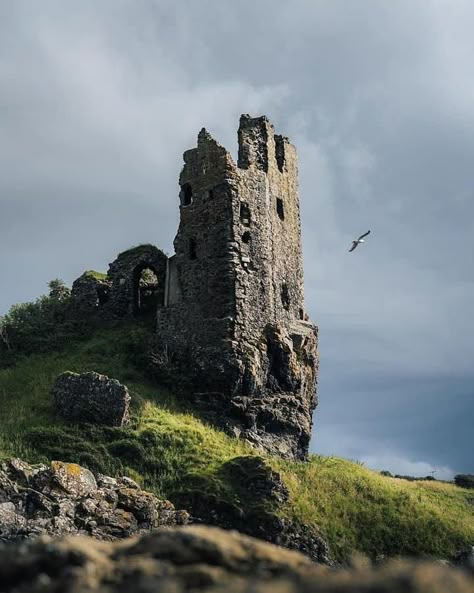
[0,0,474,477]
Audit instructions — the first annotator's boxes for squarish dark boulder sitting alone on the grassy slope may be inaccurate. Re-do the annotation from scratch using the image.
[52,371,130,426]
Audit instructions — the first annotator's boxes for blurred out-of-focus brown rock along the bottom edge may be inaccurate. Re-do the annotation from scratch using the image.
[0,526,474,593]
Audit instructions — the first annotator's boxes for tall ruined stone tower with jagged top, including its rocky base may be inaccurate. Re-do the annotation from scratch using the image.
[157,115,318,458]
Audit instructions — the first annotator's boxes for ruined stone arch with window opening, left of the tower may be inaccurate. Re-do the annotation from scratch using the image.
[108,245,168,317]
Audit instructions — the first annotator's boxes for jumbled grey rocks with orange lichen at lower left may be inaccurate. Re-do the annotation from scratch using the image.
[0,459,189,542]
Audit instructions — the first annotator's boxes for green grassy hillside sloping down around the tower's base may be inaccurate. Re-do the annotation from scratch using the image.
[0,327,474,559]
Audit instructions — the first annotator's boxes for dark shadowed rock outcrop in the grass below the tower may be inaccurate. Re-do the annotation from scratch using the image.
[174,457,332,565]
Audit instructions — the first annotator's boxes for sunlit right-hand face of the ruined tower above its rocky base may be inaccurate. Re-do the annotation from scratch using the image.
[234,116,304,340]
